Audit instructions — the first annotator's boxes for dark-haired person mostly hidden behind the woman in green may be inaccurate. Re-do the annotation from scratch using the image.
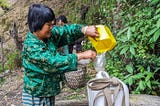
[57,15,74,54]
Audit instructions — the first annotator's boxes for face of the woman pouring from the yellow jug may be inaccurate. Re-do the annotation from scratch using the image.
[38,21,54,40]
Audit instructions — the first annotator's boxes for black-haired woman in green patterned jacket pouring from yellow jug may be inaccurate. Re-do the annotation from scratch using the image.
[22,4,98,106]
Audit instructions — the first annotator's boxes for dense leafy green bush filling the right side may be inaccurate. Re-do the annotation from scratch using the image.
[106,0,160,95]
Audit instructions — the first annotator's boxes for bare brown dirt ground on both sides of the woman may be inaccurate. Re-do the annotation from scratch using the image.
[0,66,96,106]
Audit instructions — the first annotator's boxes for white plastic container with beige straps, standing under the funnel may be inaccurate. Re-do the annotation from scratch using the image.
[87,71,129,106]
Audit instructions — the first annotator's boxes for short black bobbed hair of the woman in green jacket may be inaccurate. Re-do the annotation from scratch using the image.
[27,4,55,33]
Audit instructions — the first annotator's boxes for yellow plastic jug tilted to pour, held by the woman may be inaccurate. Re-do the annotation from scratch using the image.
[88,25,116,53]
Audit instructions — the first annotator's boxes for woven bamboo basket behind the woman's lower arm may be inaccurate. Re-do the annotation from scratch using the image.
[65,65,86,89]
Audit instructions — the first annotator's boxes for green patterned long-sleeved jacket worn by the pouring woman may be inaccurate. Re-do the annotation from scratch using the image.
[22,24,84,97]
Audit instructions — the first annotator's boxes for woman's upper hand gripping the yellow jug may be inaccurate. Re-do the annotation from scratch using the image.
[82,25,98,37]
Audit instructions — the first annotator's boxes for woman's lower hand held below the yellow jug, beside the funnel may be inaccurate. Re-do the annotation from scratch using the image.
[77,50,96,60]
